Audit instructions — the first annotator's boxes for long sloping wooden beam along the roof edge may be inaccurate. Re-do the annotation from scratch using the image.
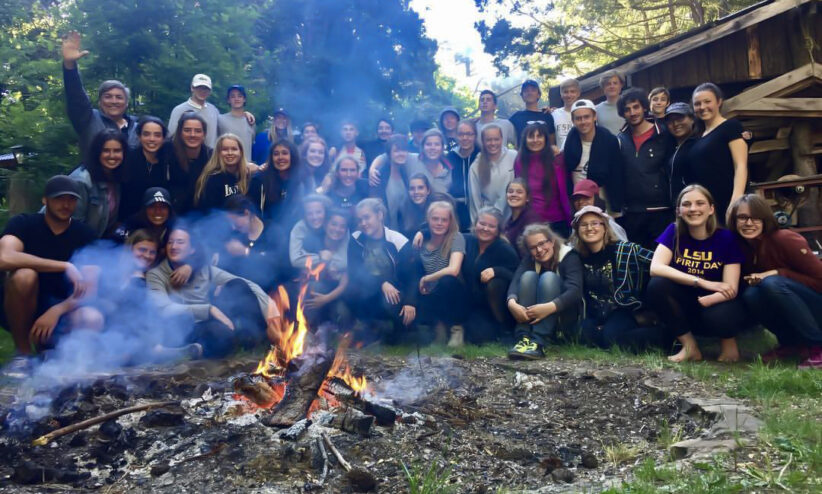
[580,0,810,93]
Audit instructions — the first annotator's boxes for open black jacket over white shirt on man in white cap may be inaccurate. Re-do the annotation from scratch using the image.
[563,125,625,211]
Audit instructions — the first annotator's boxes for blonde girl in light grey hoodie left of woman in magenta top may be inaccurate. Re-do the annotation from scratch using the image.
[468,120,517,222]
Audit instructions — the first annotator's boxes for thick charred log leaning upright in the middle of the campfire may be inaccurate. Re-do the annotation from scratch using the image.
[263,353,334,427]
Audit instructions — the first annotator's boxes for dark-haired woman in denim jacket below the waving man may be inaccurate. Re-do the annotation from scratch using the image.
[69,129,128,238]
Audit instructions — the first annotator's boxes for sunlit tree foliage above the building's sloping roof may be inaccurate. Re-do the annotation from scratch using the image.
[475,0,768,77]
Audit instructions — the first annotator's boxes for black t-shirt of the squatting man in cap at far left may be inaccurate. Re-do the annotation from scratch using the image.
[3,213,96,305]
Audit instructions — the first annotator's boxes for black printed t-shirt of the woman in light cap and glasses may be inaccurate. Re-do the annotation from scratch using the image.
[582,244,616,323]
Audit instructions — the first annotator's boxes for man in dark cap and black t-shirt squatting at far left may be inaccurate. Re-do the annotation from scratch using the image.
[0,175,96,360]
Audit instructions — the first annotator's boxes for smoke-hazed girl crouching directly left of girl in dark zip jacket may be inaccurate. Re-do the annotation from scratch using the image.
[305,209,351,328]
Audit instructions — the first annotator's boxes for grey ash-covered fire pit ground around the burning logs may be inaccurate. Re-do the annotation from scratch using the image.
[0,352,710,493]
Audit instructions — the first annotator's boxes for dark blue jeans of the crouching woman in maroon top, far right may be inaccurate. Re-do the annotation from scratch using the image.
[742,275,822,345]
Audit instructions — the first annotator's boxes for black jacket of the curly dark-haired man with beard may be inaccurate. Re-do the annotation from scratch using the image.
[617,124,675,213]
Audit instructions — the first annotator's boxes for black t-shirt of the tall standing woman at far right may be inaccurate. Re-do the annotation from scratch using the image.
[685,119,743,220]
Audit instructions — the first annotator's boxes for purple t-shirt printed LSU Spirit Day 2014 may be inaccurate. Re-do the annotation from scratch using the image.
[656,224,745,281]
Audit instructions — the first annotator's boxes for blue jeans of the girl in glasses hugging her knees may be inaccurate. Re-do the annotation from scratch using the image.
[514,271,578,345]
